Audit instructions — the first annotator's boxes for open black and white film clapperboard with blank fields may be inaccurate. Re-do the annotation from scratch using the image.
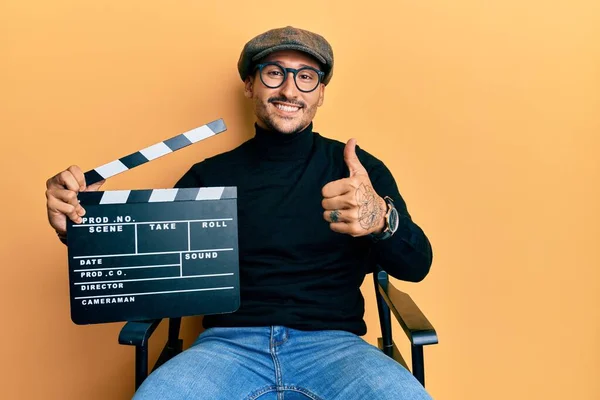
[67,119,240,325]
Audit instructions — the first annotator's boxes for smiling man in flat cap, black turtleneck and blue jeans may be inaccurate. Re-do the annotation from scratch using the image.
[47,27,432,400]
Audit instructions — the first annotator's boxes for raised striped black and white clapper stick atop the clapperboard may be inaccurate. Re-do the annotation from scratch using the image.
[84,119,227,185]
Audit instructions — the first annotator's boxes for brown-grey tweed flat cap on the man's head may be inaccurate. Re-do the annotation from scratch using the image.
[238,26,333,85]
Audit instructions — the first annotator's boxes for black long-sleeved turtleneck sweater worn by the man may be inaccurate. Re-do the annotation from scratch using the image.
[175,124,432,335]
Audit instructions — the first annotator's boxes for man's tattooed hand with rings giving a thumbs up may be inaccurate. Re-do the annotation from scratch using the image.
[321,139,387,237]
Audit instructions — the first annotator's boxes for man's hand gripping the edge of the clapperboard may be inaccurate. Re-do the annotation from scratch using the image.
[46,165,104,235]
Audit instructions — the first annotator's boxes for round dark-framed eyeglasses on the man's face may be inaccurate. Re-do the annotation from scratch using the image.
[255,62,325,93]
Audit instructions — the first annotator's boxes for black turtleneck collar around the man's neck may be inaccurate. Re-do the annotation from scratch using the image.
[254,122,314,160]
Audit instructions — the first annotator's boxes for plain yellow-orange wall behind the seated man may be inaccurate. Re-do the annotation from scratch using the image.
[0,0,600,400]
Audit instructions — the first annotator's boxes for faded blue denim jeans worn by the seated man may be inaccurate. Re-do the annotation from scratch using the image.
[134,326,431,400]
